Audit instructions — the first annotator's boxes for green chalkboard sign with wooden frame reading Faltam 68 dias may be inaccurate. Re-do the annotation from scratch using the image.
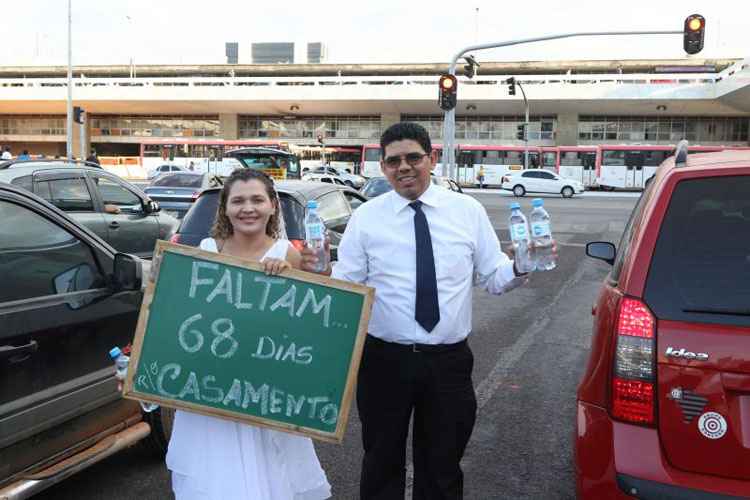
[123,241,374,442]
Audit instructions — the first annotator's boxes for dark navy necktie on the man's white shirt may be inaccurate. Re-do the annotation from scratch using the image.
[409,200,440,332]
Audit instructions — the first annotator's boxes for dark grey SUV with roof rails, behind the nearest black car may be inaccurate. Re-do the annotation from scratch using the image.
[0,161,180,258]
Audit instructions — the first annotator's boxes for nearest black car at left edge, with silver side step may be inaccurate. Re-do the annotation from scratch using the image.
[0,182,171,498]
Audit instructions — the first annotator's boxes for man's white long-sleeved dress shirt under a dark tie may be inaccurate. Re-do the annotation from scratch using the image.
[332,184,525,344]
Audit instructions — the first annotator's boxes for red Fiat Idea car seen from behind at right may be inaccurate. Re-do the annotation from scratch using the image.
[575,143,750,500]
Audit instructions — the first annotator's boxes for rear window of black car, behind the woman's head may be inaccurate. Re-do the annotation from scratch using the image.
[179,191,305,240]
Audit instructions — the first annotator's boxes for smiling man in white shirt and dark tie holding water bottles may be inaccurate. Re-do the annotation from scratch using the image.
[302,123,548,500]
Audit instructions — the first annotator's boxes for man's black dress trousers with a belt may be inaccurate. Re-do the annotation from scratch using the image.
[357,336,477,500]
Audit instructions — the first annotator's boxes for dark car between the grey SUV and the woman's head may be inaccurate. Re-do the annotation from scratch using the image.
[143,172,222,219]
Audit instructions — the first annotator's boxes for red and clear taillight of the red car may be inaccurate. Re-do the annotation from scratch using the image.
[610,298,656,425]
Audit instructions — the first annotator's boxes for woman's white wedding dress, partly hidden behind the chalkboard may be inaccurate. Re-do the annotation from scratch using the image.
[167,238,331,500]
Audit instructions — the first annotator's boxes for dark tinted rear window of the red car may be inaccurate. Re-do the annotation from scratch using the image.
[645,176,750,326]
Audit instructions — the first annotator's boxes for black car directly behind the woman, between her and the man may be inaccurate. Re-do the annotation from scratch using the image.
[172,181,367,260]
